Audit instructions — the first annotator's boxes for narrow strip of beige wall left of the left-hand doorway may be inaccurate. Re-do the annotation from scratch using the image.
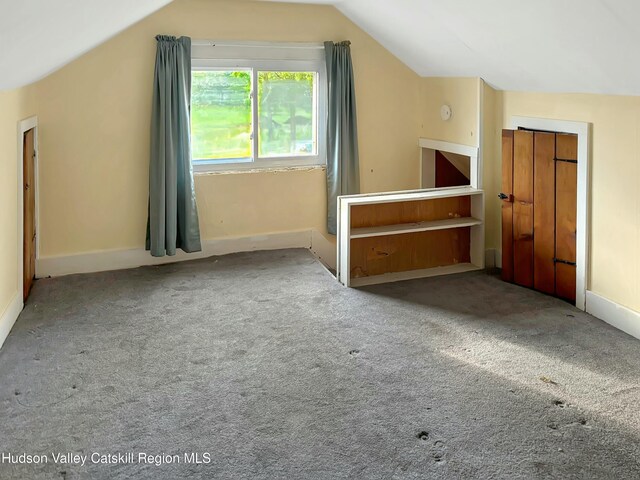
[0,87,34,318]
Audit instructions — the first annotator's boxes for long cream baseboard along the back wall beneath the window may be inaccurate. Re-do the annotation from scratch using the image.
[36,230,311,278]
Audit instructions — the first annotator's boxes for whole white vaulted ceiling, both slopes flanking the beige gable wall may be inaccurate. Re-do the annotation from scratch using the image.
[0,0,640,95]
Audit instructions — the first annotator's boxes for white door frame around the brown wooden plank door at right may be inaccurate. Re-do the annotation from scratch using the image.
[511,115,591,311]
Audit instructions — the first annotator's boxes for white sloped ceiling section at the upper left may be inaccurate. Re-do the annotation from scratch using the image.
[0,0,171,90]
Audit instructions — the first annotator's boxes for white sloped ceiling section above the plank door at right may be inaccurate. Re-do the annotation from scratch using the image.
[268,0,640,95]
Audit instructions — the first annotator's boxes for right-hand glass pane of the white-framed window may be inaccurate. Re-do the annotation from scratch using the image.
[258,72,317,157]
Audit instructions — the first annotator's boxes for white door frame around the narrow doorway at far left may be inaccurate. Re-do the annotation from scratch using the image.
[18,116,40,297]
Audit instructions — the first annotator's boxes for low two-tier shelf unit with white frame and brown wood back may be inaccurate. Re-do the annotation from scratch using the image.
[337,186,484,287]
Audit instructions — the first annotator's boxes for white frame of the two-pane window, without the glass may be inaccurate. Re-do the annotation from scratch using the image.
[191,41,328,173]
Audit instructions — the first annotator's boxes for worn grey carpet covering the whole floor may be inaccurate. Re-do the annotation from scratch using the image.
[0,250,640,480]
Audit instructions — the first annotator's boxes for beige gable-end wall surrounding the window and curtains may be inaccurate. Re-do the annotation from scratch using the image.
[35,0,419,257]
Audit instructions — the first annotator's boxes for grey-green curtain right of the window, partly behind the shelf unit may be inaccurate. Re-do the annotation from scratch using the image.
[324,42,360,235]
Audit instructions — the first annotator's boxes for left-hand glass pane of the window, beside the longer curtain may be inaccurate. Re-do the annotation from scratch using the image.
[191,71,251,160]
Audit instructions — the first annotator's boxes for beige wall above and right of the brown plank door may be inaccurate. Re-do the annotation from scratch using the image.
[496,92,640,311]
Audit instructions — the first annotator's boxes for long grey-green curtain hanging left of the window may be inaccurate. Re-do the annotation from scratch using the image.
[146,35,201,257]
